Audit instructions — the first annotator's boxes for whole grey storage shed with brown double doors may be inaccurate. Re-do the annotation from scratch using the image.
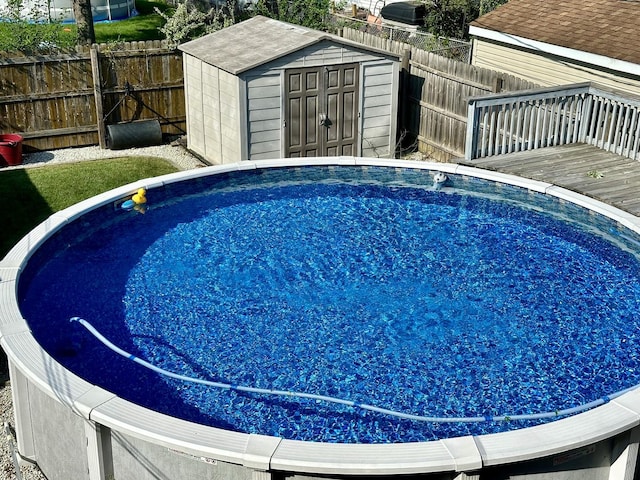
[180,16,399,164]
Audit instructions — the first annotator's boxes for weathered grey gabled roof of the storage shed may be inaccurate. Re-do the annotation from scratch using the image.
[179,15,399,75]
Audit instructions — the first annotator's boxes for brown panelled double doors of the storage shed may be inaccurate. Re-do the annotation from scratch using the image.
[285,63,359,157]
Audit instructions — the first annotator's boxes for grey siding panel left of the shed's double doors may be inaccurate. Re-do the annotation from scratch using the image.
[246,72,282,160]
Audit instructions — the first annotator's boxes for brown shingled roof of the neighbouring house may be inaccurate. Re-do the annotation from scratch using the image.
[471,0,640,64]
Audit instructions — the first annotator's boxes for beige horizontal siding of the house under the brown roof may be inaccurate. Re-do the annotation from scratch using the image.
[471,39,640,95]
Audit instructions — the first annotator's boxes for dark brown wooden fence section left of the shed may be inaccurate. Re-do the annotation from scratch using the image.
[0,41,186,152]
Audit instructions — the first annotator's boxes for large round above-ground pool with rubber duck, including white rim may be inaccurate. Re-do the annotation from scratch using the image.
[0,157,640,480]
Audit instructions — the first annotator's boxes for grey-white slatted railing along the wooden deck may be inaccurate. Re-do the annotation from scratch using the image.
[465,83,640,160]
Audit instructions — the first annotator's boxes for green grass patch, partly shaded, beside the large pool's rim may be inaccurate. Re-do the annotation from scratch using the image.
[0,157,178,258]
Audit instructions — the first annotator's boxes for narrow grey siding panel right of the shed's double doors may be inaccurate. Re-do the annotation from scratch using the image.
[360,62,398,158]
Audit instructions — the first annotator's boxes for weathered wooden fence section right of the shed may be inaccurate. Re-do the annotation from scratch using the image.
[341,28,537,161]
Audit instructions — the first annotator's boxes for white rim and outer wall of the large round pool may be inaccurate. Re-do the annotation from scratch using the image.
[0,157,640,480]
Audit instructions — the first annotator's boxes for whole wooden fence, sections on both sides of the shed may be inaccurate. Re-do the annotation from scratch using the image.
[0,28,536,161]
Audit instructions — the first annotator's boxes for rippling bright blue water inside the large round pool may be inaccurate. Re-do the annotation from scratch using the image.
[19,167,640,443]
